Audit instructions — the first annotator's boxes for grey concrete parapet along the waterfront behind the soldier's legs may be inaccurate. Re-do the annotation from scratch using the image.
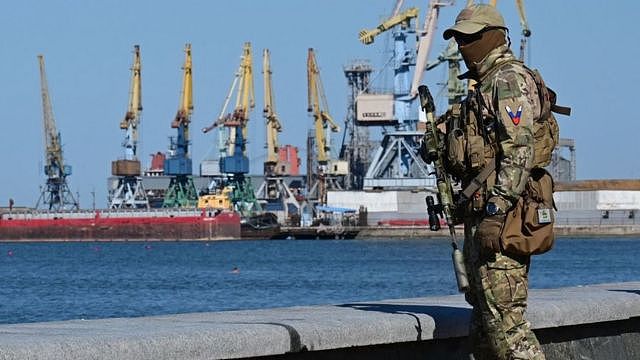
[0,282,640,359]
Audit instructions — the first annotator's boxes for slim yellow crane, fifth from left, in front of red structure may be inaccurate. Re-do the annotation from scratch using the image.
[262,49,282,176]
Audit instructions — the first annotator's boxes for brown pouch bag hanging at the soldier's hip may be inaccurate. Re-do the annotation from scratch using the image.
[500,168,555,256]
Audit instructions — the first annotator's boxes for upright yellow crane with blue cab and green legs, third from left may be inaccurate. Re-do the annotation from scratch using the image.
[162,44,198,207]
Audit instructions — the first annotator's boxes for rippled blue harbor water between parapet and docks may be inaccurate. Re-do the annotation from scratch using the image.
[0,238,640,323]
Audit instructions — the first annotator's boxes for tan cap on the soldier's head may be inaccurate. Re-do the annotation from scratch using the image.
[442,4,507,40]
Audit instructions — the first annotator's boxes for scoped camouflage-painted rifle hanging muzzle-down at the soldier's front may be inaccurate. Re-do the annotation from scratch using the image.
[418,85,469,292]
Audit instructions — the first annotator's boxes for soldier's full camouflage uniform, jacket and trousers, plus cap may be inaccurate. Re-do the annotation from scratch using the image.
[445,5,544,359]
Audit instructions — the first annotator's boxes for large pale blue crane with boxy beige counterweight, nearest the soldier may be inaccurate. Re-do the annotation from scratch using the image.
[356,0,451,189]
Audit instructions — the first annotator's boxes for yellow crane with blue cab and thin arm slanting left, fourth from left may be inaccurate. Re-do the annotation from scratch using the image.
[202,42,261,216]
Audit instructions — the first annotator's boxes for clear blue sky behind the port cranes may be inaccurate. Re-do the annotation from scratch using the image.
[0,0,640,208]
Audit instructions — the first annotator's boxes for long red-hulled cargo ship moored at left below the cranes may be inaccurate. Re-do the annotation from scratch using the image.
[0,209,241,241]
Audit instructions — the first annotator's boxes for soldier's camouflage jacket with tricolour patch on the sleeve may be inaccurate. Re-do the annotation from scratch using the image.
[476,45,540,209]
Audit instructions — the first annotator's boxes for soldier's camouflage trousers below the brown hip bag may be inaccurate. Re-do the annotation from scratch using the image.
[464,221,545,360]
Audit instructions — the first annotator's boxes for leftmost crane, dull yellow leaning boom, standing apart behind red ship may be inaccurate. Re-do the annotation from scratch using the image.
[36,55,79,211]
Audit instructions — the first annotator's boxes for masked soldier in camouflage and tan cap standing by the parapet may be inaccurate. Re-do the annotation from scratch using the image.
[444,4,544,359]
